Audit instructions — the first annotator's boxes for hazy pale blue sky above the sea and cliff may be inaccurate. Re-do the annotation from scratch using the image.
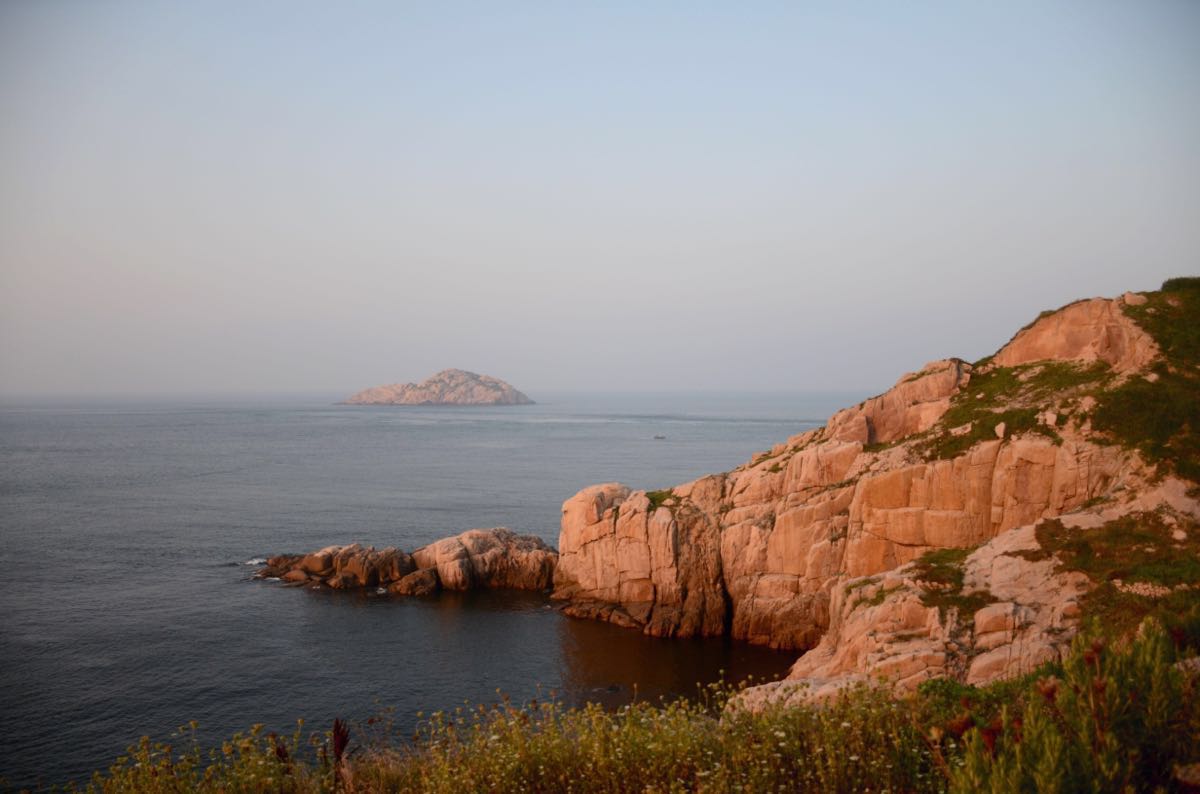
[0,0,1200,398]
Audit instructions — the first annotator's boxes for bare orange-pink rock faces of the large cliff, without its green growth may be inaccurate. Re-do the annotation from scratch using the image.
[553,287,1194,697]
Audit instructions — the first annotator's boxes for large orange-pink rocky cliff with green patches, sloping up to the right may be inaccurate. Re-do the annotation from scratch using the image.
[554,279,1200,704]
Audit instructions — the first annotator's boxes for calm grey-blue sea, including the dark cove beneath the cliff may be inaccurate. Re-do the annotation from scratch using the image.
[0,395,862,786]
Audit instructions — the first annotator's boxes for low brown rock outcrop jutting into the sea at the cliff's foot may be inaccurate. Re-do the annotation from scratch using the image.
[256,528,558,595]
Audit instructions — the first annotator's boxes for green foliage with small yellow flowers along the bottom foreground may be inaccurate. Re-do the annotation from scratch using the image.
[88,622,1200,794]
